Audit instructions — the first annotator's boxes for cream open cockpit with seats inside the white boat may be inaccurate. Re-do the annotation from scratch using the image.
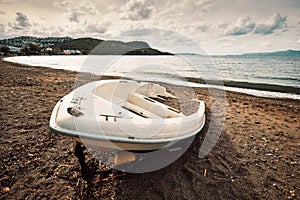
[94,81,183,118]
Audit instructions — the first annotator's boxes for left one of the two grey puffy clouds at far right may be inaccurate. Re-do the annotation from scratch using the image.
[224,16,255,35]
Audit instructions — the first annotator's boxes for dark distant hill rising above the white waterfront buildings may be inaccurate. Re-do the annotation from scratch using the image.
[0,36,173,55]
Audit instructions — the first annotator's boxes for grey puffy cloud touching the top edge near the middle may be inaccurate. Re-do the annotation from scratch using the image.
[121,0,155,20]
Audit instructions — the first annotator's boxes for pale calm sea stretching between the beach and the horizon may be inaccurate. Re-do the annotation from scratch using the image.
[5,55,300,99]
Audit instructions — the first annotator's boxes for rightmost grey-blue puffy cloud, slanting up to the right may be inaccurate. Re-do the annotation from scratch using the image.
[254,12,287,35]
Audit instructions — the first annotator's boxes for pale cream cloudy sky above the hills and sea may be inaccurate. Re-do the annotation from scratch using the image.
[0,0,300,55]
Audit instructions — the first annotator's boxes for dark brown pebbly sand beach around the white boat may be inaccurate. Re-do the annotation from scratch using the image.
[0,60,300,199]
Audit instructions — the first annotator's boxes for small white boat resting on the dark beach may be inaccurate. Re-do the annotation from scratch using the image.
[50,80,205,151]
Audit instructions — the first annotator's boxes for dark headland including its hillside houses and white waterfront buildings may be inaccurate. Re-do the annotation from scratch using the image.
[0,36,170,56]
